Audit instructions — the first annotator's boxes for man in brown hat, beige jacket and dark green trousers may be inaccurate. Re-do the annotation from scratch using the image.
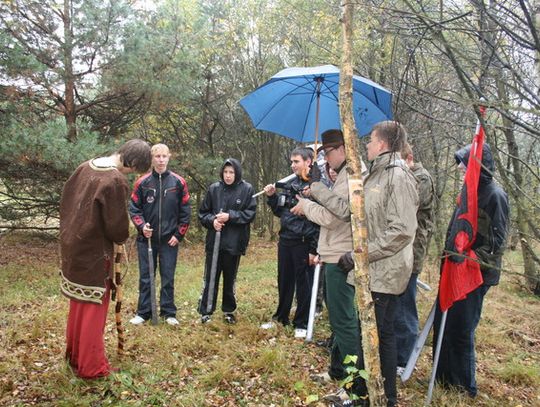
[291,129,369,406]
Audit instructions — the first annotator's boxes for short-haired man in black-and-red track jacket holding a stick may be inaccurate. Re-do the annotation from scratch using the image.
[129,144,191,325]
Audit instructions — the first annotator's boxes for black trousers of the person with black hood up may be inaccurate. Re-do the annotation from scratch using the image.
[198,251,240,315]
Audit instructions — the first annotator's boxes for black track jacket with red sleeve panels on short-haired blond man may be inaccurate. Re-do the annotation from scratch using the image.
[129,170,191,243]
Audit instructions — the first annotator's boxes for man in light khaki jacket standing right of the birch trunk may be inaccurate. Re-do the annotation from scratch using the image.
[332,121,418,406]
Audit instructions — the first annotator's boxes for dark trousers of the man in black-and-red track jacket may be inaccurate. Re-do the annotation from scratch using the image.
[137,239,178,319]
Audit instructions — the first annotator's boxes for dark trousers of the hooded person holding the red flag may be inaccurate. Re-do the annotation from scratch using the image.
[433,285,489,397]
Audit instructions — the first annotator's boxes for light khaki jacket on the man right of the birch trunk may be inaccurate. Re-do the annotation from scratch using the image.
[364,153,418,295]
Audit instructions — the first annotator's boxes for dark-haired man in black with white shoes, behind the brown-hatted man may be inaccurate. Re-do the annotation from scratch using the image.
[261,147,319,338]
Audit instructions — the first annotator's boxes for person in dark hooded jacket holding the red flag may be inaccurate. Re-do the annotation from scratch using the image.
[433,144,509,397]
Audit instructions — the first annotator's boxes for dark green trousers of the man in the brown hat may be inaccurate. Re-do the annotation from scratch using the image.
[325,263,368,402]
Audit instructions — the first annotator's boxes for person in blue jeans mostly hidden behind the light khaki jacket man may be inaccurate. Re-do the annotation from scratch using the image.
[394,143,435,376]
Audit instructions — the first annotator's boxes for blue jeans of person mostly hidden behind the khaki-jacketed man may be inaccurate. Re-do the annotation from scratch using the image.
[394,273,418,367]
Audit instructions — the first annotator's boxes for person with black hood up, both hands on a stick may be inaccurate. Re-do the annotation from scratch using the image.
[198,158,257,324]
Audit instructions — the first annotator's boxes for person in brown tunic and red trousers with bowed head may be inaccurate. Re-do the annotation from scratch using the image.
[60,140,151,379]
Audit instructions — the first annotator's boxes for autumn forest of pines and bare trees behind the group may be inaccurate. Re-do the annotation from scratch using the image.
[0,0,540,403]
